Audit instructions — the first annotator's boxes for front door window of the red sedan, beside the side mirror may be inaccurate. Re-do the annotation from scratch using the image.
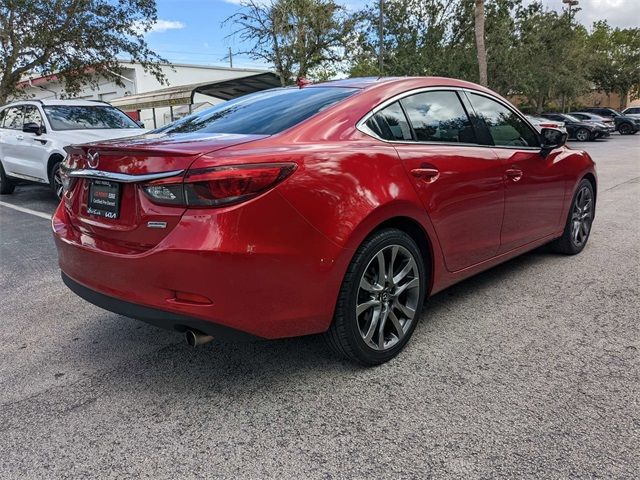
[469,93,540,147]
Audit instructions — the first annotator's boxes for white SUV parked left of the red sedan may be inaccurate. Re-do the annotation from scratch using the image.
[0,100,147,198]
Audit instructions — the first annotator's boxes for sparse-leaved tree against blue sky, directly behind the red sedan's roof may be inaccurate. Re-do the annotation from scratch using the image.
[223,0,351,85]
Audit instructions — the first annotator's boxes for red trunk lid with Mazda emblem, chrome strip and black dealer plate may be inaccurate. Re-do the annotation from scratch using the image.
[63,134,264,253]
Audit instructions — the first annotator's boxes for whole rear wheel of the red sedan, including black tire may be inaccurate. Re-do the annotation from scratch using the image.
[325,228,427,366]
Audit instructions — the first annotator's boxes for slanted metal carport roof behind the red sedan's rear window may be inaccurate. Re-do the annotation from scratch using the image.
[109,72,280,111]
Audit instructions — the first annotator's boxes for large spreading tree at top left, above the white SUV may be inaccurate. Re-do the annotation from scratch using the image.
[0,0,164,104]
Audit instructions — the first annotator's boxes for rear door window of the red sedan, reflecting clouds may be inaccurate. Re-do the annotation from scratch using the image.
[401,91,476,143]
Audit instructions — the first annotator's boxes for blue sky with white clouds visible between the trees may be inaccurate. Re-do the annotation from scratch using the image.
[146,0,640,68]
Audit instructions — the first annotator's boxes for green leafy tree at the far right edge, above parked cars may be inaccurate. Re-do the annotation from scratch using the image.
[588,21,640,109]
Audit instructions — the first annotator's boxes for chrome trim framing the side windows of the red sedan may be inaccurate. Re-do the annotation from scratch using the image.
[356,86,541,151]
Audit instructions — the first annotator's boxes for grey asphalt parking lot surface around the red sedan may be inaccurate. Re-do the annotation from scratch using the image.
[0,134,640,479]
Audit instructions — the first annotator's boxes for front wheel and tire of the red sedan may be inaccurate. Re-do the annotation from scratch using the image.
[550,178,596,255]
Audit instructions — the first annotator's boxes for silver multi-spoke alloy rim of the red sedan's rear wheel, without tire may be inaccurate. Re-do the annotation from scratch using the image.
[356,245,421,351]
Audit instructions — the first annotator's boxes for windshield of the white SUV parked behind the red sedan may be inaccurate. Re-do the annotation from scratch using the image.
[44,105,140,130]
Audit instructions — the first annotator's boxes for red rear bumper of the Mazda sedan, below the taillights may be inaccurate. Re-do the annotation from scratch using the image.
[52,192,350,339]
